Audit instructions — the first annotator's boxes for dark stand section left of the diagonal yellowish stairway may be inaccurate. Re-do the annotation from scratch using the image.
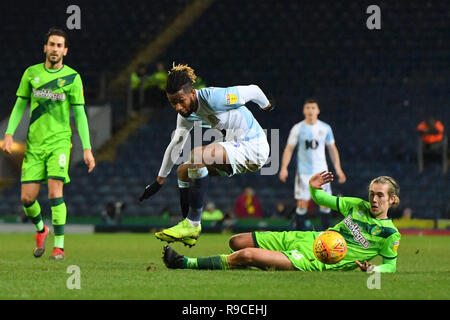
[0,0,188,118]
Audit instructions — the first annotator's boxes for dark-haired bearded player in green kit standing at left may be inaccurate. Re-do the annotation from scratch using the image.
[2,28,95,260]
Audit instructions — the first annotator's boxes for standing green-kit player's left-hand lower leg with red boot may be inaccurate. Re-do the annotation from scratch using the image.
[21,183,48,258]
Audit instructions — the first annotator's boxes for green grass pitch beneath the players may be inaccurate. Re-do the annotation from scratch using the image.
[0,233,450,300]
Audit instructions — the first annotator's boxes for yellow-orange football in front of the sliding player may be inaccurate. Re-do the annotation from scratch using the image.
[313,230,347,264]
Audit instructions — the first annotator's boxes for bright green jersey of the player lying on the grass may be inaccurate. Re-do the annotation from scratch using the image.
[310,188,401,270]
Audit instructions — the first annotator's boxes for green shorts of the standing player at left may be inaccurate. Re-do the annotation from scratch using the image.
[21,143,72,183]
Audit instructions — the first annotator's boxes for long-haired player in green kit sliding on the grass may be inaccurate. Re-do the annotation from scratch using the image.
[163,171,400,272]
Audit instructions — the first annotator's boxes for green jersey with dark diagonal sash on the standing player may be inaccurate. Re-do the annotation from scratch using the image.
[17,63,85,150]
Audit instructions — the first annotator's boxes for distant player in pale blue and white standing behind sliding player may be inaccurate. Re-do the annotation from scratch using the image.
[279,99,347,231]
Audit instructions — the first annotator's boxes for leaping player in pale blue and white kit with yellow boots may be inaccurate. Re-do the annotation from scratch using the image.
[140,64,272,247]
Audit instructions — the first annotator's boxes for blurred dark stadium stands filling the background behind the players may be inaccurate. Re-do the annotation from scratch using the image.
[0,0,450,232]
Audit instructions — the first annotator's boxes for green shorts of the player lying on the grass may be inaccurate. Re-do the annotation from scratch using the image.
[252,231,325,271]
